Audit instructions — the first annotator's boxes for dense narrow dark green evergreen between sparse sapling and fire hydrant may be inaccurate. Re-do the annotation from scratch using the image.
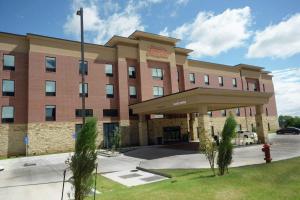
[217,114,237,176]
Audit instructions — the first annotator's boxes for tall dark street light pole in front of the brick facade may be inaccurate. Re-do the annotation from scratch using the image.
[76,7,86,125]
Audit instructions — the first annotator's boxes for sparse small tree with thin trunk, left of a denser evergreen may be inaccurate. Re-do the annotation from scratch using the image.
[199,129,218,176]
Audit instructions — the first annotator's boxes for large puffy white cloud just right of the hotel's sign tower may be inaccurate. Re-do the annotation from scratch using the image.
[164,7,251,57]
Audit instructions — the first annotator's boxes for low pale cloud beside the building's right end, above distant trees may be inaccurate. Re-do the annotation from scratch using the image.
[273,68,300,116]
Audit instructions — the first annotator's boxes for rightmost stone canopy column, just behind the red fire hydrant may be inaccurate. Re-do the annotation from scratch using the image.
[255,105,268,143]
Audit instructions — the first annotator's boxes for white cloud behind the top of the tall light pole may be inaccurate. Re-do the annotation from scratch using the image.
[64,0,162,44]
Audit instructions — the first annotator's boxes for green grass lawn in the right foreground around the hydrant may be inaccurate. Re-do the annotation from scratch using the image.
[88,158,300,200]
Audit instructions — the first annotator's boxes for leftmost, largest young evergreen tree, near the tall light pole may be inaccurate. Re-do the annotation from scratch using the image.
[69,118,97,200]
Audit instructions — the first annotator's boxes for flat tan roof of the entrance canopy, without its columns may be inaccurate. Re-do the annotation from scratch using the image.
[129,87,273,114]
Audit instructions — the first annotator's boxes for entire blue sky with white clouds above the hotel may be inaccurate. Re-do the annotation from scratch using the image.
[0,0,300,115]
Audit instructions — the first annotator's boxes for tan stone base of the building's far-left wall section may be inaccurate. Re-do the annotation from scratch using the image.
[0,124,27,157]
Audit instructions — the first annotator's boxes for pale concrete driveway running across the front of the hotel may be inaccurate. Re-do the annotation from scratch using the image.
[0,134,300,200]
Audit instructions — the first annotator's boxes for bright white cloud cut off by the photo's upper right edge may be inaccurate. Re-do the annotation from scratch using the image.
[247,14,300,58]
